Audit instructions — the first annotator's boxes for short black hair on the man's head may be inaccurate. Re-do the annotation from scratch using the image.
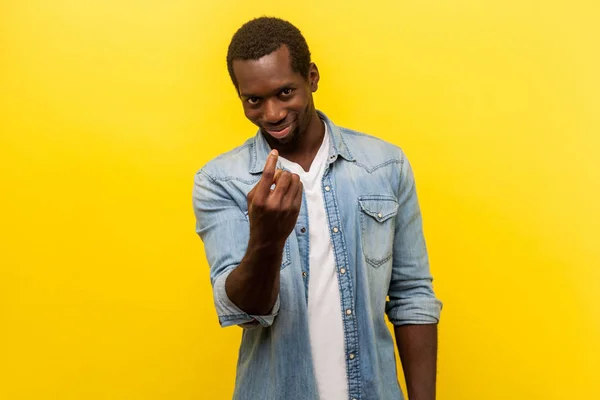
[227,17,310,89]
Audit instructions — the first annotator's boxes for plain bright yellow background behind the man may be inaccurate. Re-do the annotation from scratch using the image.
[0,0,600,400]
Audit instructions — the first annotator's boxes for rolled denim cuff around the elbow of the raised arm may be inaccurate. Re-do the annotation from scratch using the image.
[213,268,279,328]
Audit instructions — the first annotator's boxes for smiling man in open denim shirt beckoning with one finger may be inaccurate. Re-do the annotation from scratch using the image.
[193,18,441,400]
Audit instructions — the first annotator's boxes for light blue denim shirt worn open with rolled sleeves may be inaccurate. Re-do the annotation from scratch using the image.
[193,113,441,400]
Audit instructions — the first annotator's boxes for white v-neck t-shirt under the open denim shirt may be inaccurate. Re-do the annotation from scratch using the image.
[279,124,348,400]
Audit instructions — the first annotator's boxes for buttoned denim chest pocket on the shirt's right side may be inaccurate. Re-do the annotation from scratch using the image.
[358,195,398,268]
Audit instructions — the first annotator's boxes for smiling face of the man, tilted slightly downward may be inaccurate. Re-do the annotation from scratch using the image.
[233,45,319,147]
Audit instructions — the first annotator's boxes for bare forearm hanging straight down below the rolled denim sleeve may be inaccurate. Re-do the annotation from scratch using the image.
[394,324,437,400]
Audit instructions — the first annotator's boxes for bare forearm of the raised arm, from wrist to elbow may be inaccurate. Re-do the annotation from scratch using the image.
[225,240,283,315]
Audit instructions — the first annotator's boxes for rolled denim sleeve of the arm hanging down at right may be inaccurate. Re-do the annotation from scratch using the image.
[386,155,442,326]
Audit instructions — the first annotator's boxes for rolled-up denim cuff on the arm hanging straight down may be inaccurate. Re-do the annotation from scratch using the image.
[386,297,442,326]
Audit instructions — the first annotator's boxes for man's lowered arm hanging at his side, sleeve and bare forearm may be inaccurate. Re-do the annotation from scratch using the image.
[386,157,442,400]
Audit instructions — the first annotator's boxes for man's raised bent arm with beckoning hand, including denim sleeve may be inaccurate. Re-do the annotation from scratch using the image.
[193,149,302,327]
